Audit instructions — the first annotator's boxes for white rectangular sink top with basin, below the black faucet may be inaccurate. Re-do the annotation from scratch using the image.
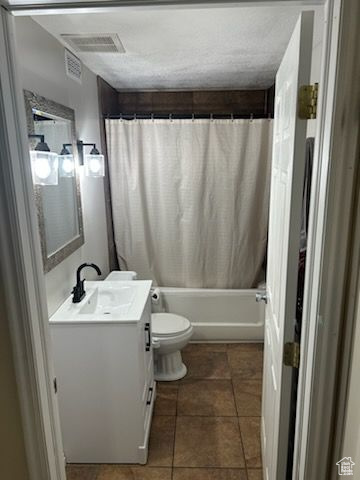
[50,280,151,323]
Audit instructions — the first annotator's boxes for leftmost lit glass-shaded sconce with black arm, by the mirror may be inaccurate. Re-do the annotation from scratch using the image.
[29,134,59,185]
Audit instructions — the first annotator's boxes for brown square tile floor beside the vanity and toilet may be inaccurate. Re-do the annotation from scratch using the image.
[67,344,262,480]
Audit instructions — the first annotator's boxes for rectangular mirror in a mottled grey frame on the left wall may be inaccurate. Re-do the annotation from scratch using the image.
[24,90,84,273]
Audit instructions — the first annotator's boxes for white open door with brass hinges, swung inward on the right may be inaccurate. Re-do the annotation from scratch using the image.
[261,12,313,480]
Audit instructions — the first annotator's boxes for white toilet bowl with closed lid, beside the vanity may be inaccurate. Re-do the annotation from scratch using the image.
[151,313,194,382]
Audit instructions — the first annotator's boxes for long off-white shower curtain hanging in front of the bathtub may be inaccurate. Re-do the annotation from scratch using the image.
[106,119,272,288]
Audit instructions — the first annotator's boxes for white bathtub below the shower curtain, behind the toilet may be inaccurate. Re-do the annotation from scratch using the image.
[159,287,265,342]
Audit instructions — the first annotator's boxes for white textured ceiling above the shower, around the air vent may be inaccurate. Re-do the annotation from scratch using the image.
[33,6,321,90]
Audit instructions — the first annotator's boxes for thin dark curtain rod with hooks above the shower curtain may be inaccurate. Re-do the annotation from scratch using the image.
[103,113,274,120]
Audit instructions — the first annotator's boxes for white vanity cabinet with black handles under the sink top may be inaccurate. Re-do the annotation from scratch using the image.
[50,282,156,464]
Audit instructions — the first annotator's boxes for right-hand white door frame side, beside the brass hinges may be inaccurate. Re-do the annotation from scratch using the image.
[293,0,360,480]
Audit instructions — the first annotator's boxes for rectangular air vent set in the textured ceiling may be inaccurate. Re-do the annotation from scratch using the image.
[61,33,125,53]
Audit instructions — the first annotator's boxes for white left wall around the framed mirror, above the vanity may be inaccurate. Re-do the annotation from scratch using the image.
[16,17,109,315]
